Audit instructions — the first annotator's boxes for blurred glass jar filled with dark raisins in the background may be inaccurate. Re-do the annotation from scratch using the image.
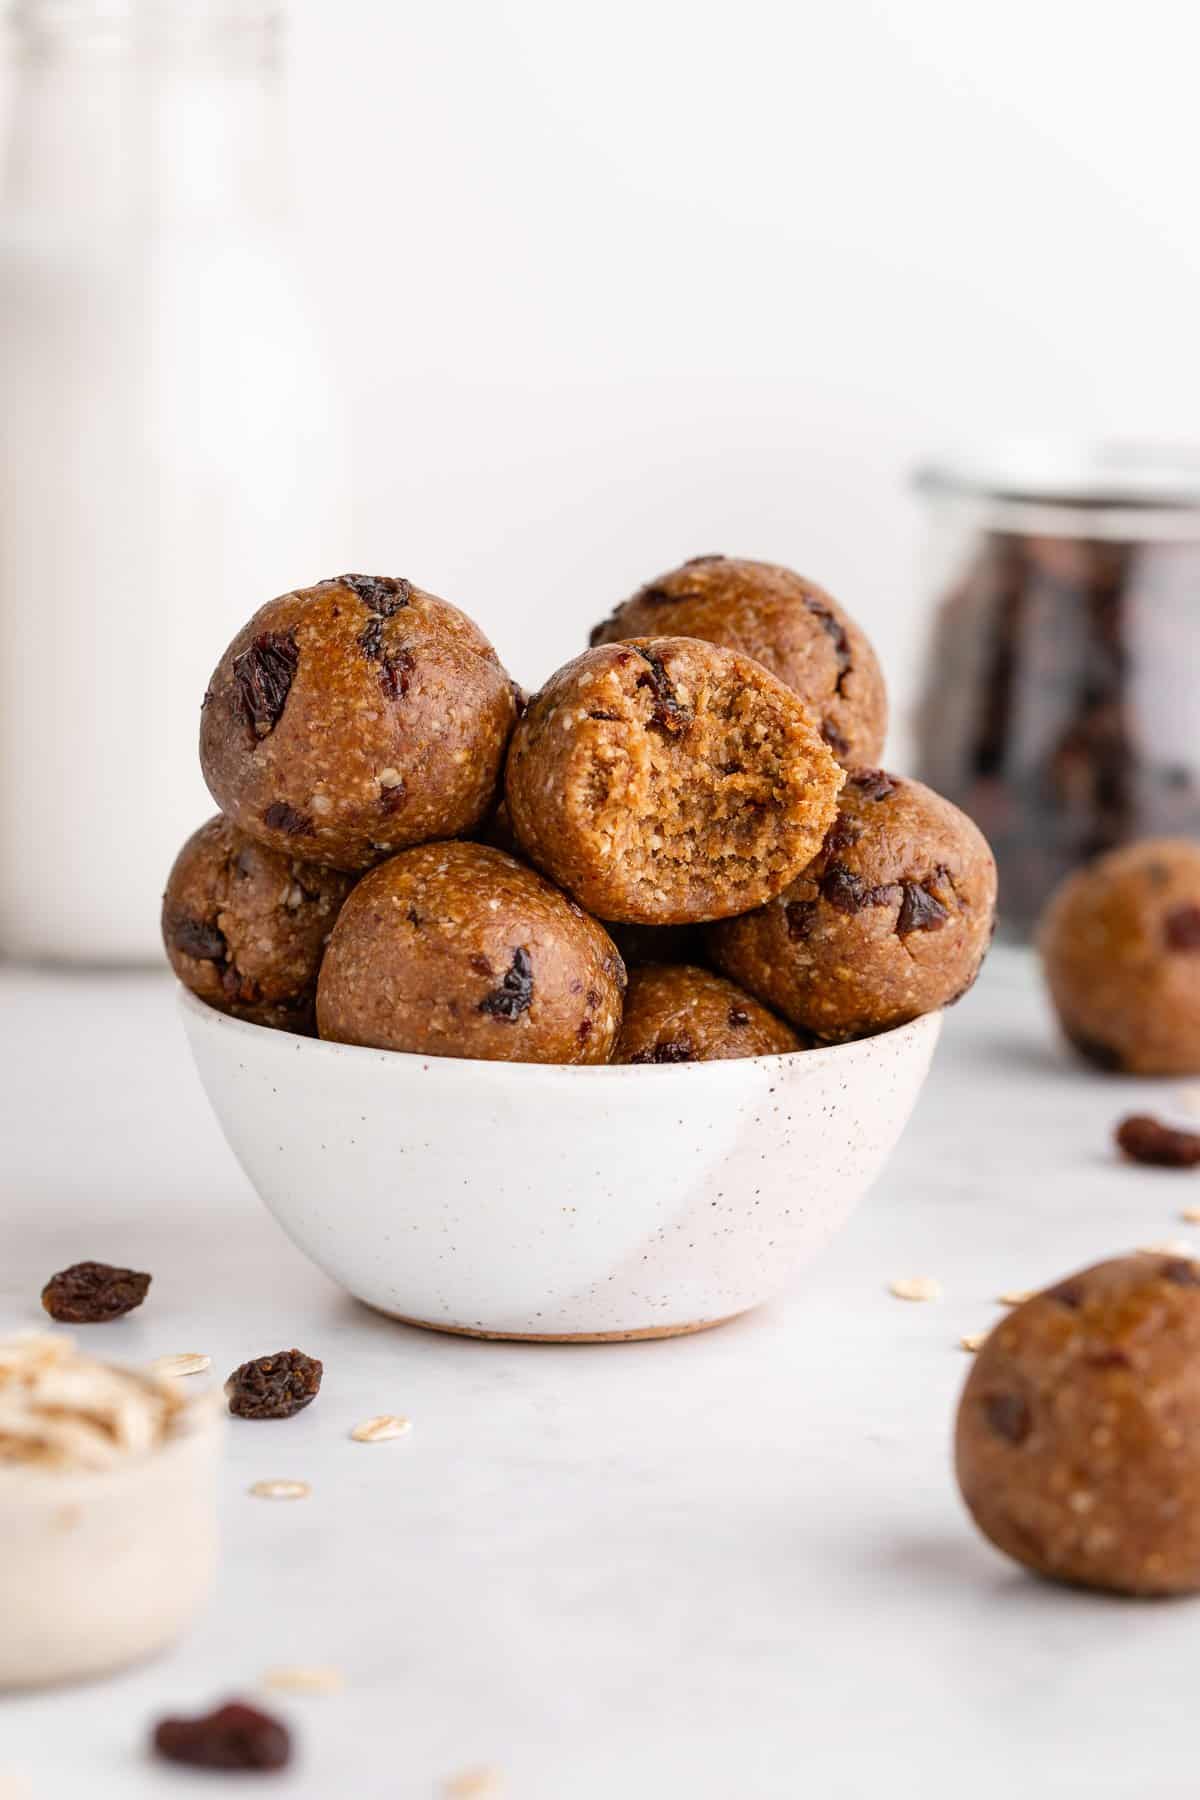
[918,446,1200,938]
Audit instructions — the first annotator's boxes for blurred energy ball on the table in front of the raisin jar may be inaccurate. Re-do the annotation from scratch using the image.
[1038,837,1200,1075]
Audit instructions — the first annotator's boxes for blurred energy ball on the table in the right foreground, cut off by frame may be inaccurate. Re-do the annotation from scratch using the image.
[955,1253,1200,1595]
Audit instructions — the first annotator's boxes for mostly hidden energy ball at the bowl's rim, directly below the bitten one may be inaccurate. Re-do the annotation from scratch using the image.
[612,963,804,1062]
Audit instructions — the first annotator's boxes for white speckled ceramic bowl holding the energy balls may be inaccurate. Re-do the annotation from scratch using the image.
[180,990,941,1341]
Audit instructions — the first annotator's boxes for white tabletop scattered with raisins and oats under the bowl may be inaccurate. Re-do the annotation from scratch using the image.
[0,952,1200,1800]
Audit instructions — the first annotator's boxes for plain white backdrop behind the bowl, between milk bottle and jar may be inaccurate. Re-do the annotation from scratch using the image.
[291,0,1200,730]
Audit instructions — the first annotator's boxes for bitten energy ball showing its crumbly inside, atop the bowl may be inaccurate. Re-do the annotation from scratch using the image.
[506,637,844,925]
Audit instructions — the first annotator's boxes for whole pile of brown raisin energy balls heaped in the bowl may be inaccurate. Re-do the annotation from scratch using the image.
[162,556,995,1064]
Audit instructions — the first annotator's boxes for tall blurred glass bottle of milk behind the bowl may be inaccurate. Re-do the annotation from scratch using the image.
[0,0,353,963]
